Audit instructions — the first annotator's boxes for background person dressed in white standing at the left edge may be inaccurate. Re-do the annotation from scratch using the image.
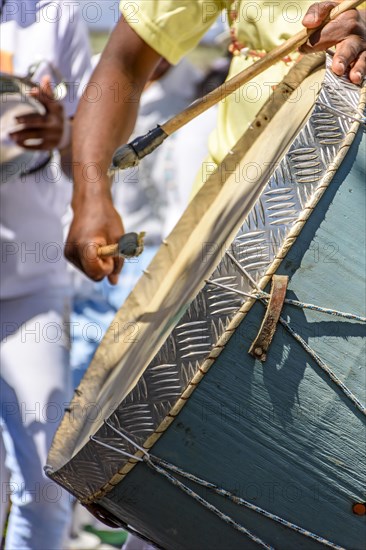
[0,0,90,550]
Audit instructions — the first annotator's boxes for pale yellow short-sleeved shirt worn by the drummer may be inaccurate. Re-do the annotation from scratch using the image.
[120,0,314,187]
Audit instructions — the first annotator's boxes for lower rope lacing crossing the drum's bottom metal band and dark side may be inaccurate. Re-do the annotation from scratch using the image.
[90,420,345,550]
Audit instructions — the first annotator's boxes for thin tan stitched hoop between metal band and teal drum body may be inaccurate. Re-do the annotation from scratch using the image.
[48,55,366,504]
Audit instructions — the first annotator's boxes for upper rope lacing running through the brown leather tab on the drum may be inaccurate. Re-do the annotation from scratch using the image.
[205,252,366,416]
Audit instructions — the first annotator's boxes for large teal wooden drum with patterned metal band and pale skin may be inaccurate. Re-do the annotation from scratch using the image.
[46,60,366,550]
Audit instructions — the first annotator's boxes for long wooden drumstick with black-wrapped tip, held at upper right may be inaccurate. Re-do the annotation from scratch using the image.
[108,0,364,176]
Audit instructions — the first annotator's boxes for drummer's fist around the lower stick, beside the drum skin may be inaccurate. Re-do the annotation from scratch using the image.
[65,195,124,284]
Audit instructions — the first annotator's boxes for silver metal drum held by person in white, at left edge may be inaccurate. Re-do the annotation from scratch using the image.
[0,73,51,183]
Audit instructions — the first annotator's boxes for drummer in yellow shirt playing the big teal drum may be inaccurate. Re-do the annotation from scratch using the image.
[65,0,366,284]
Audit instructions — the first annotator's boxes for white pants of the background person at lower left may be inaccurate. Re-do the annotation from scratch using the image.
[0,291,71,550]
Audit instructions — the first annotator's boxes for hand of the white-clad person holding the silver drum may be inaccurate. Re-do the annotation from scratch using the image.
[10,77,65,151]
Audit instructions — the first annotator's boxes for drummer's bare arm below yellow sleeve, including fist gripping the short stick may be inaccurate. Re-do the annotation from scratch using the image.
[65,19,160,284]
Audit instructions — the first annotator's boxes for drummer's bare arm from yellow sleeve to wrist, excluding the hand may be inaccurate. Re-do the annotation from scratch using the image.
[73,17,159,206]
